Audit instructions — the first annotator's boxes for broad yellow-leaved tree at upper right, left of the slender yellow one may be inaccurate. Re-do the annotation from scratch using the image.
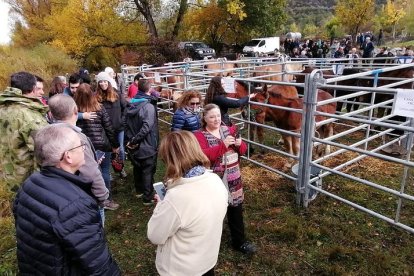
[335,0,375,36]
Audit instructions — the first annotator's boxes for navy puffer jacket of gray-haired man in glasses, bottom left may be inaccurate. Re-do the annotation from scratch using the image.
[13,167,120,276]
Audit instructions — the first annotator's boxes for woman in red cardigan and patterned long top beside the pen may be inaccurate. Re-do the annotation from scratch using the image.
[194,104,256,254]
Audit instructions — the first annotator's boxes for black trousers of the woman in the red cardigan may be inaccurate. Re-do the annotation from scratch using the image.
[227,204,246,248]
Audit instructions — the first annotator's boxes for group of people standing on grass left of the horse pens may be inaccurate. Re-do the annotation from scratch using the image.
[0,68,256,275]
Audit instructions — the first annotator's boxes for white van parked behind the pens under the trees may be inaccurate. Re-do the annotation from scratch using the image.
[243,36,280,57]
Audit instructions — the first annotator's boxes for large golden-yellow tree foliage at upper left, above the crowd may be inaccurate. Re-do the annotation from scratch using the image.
[45,0,147,59]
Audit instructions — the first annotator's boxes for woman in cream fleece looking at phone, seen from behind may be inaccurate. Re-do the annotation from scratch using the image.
[147,131,228,275]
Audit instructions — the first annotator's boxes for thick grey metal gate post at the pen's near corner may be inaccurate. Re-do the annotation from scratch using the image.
[296,70,320,208]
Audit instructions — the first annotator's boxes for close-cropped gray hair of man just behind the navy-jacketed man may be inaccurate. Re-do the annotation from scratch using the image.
[48,94,78,121]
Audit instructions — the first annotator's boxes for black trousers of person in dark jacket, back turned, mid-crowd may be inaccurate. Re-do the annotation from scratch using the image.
[132,155,157,201]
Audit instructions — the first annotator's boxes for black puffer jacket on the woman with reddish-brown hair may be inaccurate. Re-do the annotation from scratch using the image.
[76,108,119,152]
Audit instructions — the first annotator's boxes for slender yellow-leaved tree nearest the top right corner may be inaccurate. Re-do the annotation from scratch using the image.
[379,0,407,39]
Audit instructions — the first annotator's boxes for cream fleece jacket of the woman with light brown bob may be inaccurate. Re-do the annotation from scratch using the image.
[147,171,228,276]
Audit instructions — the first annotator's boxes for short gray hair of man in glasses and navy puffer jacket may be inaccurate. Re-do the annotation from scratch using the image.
[34,124,80,167]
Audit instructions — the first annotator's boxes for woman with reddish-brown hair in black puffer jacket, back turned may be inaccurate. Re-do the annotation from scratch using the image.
[73,83,119,210]
